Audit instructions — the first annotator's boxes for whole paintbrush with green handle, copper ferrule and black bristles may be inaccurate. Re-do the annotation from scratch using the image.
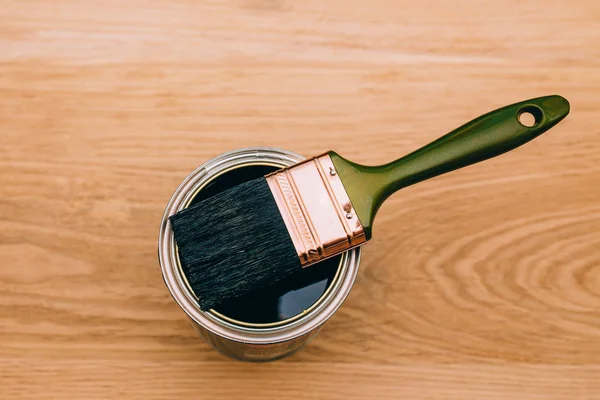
[170,96,569,310]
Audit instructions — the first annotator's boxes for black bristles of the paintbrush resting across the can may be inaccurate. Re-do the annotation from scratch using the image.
[169,178,301,310]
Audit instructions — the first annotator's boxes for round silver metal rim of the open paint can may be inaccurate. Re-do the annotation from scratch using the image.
[158,147,361,344]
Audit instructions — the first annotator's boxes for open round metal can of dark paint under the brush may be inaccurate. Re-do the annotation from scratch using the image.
[158,147,360,361]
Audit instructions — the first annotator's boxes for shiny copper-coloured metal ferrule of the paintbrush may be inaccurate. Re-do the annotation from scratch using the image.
[266,153,367,267]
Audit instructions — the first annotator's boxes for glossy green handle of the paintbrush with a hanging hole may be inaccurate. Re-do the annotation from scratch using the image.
[329,96,569,239]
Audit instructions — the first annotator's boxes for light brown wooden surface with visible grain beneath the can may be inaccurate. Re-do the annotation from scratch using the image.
[0,0,600,400]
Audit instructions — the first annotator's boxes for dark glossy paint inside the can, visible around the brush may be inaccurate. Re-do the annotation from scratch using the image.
[183,164,342,328]
